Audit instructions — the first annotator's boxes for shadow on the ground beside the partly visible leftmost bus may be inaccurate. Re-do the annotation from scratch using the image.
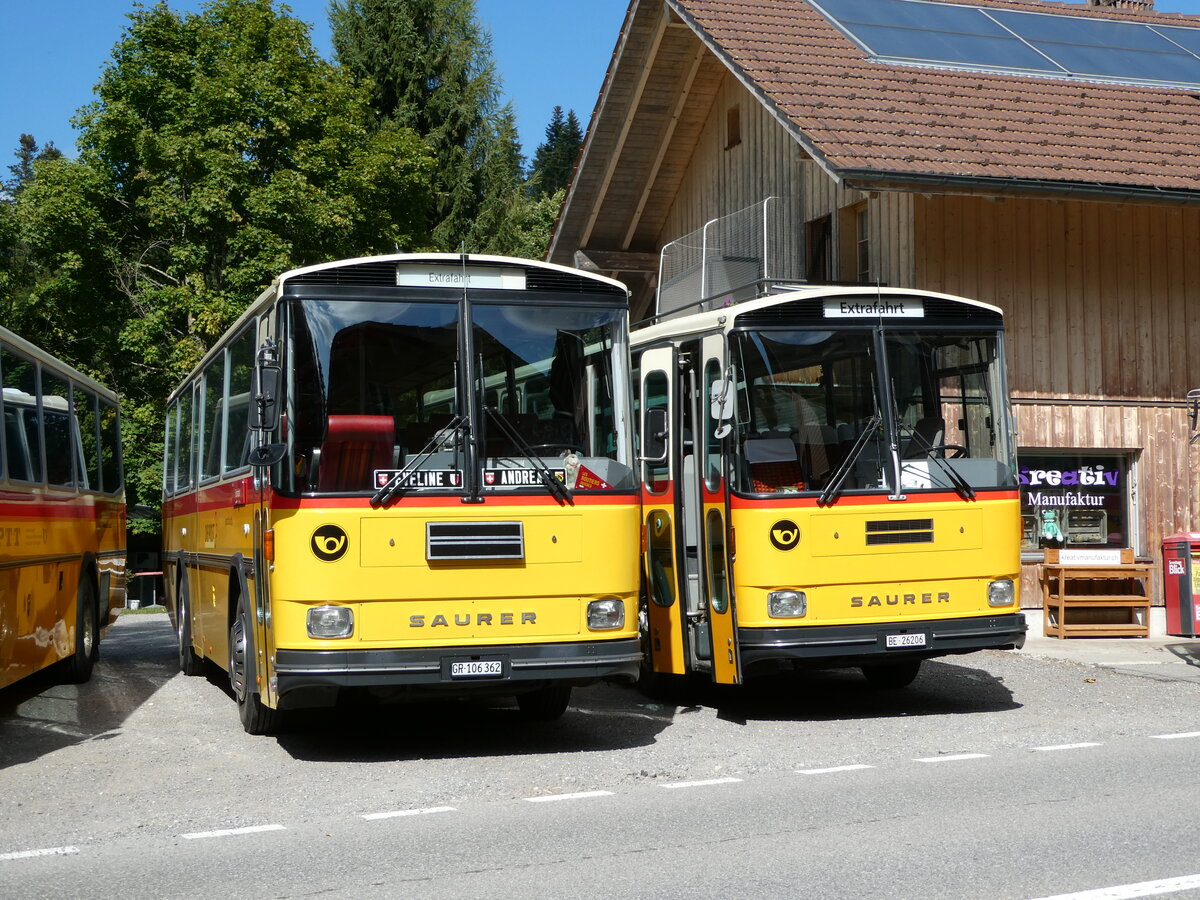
[0,614,179,769]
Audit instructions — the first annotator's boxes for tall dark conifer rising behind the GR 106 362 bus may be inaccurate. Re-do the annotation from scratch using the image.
[330,0,508,250]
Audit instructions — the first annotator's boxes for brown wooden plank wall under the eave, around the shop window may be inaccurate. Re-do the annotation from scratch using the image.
[913,197,1200,604]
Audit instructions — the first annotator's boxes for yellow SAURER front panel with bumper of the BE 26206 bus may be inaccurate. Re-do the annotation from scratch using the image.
[732,497,1024,662]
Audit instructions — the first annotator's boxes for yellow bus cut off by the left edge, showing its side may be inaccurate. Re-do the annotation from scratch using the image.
[0,328,125,688]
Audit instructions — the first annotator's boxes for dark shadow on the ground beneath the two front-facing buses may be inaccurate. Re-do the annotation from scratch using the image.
[276,661,1021,762]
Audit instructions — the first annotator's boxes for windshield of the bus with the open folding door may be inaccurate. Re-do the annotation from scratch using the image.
[731,329,1015,499]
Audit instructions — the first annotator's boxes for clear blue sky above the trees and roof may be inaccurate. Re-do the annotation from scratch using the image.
[0,0,1200,165]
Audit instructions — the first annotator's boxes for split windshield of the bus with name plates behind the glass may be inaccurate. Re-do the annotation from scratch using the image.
[283,299,634,493]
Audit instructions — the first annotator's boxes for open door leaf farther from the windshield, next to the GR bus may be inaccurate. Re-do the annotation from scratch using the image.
[640,347,688,674]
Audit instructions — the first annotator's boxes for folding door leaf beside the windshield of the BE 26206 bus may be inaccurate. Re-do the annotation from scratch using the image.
[692,334,742,684]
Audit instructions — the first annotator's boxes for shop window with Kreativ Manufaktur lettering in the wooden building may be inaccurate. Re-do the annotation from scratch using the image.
[1018,450,1136,552]
